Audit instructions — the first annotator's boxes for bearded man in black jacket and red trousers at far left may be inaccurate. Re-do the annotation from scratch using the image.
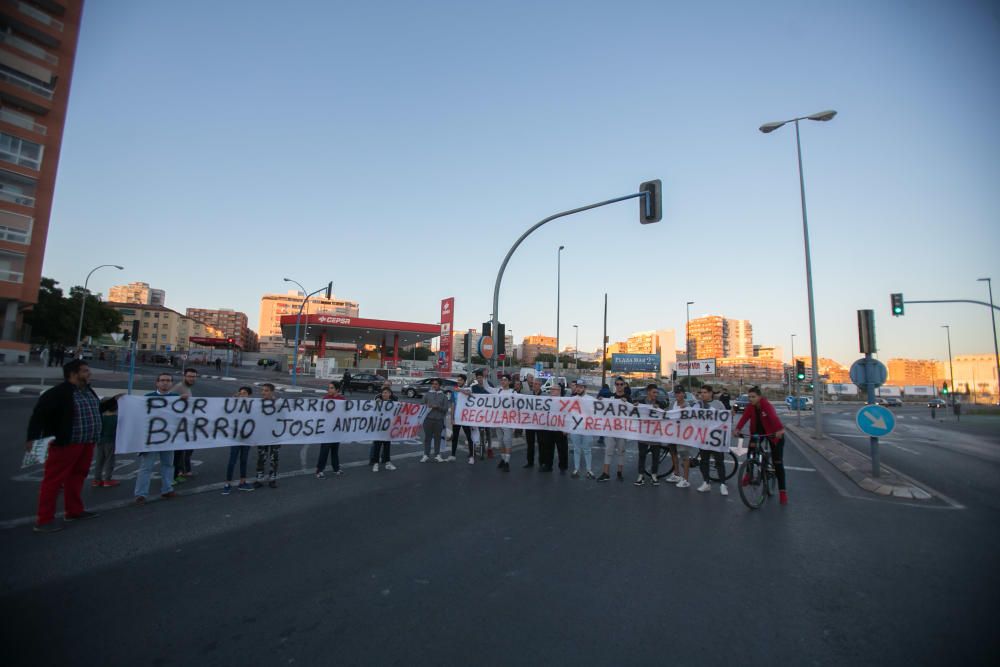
[25,359,101,533]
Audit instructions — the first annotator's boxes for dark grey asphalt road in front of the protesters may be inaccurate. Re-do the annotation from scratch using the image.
[0,381,1000,667]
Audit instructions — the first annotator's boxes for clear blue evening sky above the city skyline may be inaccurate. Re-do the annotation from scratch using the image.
[44,0,1000,362]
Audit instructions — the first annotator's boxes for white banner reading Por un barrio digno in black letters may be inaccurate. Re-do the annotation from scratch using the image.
[115,396,427,454]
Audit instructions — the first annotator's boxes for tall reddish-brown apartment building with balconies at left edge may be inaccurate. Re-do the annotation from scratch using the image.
[0,0,83,363]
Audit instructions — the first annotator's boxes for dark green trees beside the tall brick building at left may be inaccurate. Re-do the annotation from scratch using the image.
[24,278,122,345]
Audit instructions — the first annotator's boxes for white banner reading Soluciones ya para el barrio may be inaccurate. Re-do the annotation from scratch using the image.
[455,393,733,452]
